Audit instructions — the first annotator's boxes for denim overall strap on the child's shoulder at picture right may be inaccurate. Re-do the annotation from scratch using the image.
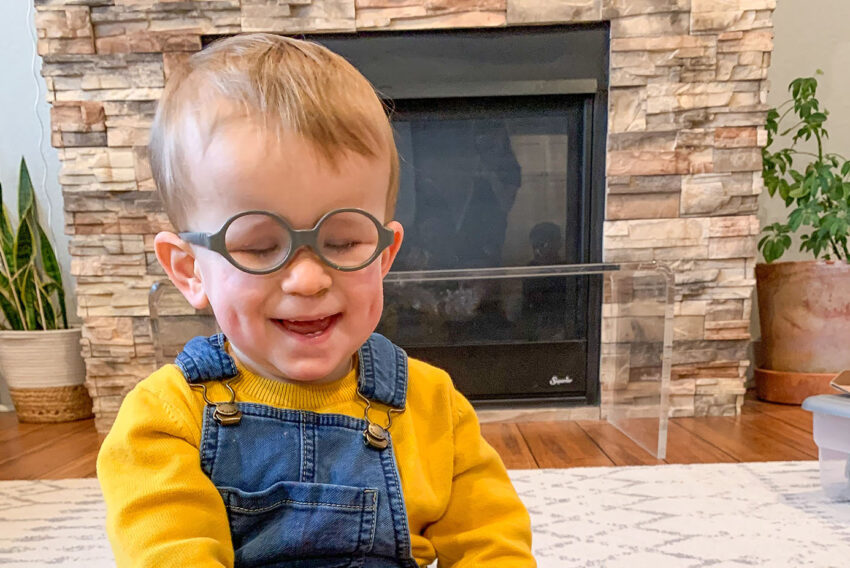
[357,333,407,410]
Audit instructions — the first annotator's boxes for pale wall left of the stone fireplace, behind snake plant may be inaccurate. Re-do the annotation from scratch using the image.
[0,0,79,410]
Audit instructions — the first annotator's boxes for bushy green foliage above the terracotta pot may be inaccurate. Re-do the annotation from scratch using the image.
[758,70,850,262]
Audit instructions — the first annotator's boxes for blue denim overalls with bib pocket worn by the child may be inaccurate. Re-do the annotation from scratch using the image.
[175,334,416,568]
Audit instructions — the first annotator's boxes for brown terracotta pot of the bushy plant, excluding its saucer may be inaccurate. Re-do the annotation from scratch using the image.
[756,261,850,374]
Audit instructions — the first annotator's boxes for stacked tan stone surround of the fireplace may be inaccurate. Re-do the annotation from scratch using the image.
[35,0,775,431]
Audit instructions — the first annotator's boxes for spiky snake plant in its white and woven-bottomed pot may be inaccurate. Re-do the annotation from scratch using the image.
[0,159,92,422]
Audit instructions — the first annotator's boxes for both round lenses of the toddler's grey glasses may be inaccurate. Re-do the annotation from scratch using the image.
[224,211,379,271]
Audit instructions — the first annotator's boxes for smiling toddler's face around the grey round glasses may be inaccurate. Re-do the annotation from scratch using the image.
[178,120,402,381]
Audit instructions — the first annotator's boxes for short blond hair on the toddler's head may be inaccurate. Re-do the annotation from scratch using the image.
[149,34,399,230]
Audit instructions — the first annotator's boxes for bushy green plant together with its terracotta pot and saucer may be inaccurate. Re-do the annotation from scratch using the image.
[755,71,850,404]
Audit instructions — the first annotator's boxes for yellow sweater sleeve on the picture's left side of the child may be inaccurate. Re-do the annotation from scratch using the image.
[97,374,234,568]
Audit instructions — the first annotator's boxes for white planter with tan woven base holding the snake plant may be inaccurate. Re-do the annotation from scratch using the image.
[0,329,92,422]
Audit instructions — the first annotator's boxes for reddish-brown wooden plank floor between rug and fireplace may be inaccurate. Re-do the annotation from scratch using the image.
[0,396,818,480]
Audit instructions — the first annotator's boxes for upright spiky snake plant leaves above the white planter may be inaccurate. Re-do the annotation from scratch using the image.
[0,158,68,331]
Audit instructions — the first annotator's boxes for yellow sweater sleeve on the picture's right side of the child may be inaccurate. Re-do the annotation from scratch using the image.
[425,391,537,568]
